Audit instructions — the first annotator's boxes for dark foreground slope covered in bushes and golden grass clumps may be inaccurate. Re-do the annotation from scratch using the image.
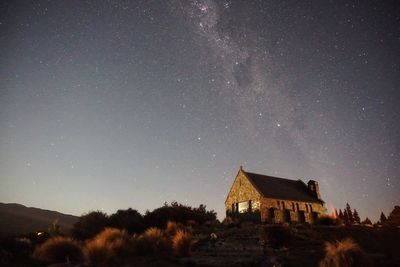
[0,203,400,267]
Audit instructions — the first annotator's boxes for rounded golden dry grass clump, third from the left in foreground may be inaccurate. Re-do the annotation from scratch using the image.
[136,227,171,257]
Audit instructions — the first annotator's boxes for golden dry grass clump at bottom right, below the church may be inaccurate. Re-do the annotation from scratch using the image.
[319,238,371,267]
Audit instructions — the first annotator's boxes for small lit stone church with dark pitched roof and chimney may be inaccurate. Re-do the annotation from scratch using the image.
[225,166,326,224]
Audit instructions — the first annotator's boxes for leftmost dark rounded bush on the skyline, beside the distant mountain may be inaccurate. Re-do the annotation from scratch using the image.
[72,211,109,240]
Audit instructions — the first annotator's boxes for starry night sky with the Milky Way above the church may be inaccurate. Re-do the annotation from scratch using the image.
[0,0,400,220]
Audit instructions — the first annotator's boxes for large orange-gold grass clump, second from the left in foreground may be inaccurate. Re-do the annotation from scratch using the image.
[84,228,133,266]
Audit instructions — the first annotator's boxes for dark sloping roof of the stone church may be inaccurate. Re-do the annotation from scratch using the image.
[243,171,323,203]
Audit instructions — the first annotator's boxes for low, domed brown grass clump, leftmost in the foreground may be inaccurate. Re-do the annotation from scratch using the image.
[33,236,82,263]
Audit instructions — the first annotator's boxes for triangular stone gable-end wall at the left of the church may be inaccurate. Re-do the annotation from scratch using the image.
[225,170,261,212]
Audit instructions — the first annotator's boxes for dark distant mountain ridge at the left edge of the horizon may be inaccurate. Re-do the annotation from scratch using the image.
[0,203,79,235]
